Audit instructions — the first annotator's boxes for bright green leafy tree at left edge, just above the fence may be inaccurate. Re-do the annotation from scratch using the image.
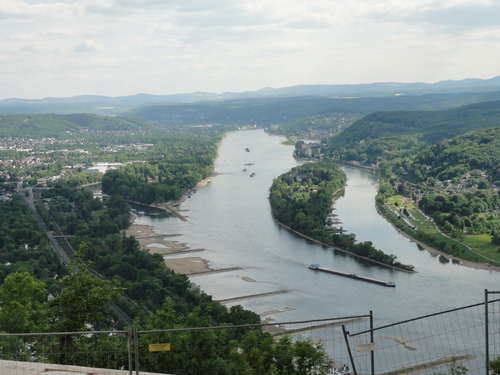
[0,272,47,333]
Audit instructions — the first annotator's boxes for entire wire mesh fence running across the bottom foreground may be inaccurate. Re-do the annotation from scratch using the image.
[0,292,500,375]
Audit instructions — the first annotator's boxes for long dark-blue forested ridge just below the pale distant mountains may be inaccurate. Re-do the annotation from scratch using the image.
[124,92,500,126]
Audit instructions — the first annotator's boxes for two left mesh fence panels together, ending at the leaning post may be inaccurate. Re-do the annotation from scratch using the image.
[0,315,370,375]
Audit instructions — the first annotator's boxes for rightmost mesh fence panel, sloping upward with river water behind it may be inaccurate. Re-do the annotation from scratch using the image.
[348,300,500,375]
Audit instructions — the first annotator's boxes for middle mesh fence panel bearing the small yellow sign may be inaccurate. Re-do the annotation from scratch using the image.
[137,315,370,374]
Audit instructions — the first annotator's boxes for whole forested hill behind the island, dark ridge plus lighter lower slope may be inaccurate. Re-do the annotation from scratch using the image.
[296,101,500,169]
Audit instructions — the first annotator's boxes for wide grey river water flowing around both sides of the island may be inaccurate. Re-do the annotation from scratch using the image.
[136,130,500,370]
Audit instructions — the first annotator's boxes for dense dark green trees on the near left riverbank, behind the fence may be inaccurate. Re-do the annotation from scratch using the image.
[0,183,332,374]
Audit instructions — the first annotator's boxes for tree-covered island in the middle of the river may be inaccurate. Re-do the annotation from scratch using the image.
[269,163,413,270]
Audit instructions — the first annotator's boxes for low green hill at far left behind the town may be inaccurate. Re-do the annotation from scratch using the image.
[0,114,155,138]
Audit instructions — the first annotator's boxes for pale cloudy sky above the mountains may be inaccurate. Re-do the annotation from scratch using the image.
[0,0,500,99]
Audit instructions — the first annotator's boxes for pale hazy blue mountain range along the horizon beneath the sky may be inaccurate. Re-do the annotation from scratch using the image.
[0,76,500,115]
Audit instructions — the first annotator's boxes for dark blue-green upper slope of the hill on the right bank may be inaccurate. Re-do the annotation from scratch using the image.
[332,101,500,147]
